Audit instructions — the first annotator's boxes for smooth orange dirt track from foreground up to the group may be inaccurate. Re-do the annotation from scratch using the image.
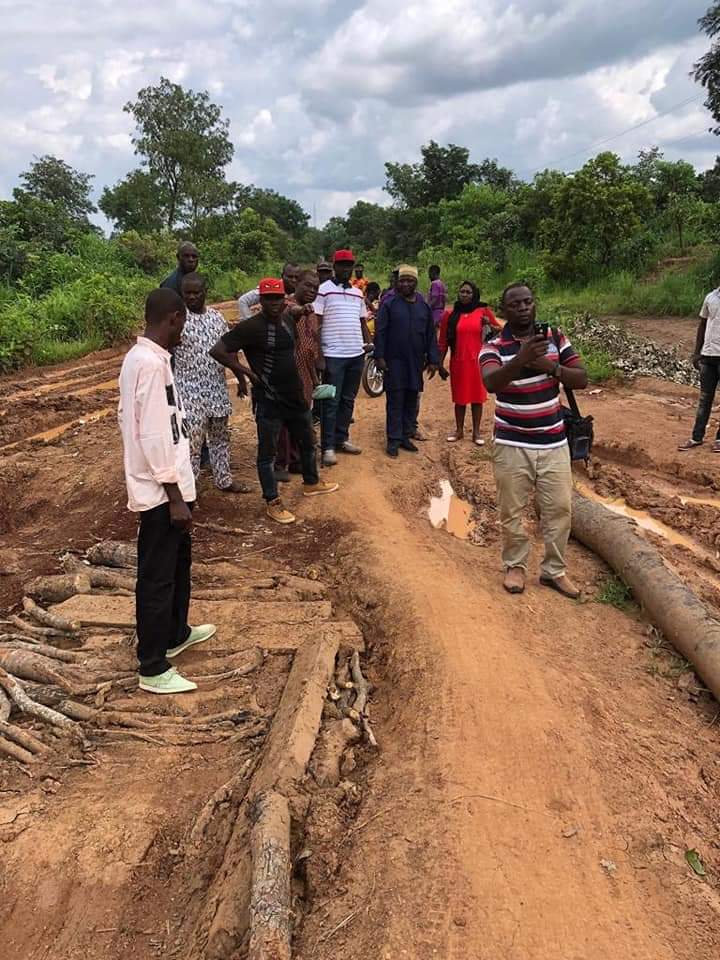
[294,390,720,960]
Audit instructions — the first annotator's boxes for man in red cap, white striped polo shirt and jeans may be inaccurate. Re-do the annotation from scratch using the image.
[315,250,371,467]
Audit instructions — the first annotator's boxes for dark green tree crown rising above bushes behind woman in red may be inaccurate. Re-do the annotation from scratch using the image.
[385,140,480,209]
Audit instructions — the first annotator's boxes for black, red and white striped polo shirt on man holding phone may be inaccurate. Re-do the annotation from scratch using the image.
[480,324,580,450]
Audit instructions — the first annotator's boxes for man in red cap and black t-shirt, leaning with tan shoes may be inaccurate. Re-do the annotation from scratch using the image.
[210,277,338,523]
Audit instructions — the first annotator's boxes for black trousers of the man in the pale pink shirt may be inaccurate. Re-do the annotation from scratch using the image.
[135,503,192,677]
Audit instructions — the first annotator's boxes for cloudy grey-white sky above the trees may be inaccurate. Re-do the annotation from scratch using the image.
[0,0,720,225]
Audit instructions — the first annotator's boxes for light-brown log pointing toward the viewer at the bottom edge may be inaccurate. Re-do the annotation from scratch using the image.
[248,791,292,960]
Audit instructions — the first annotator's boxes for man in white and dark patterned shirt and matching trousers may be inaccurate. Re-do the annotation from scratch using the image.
[175,273,249,493]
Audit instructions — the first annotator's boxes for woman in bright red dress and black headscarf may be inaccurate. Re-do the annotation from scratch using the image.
[439,280,502,447]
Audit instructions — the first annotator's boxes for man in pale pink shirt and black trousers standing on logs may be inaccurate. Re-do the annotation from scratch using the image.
[118,288,215,694]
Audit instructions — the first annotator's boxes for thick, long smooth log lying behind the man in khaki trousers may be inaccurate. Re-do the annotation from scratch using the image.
[572,494,720,700]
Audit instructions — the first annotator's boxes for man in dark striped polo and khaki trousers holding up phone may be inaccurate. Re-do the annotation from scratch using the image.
[480,283,587,599]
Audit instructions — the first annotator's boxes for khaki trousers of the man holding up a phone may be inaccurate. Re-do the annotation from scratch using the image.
[494,443,572,580]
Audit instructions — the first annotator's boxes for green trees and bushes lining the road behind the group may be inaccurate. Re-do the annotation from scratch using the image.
[0,70,720,379]
